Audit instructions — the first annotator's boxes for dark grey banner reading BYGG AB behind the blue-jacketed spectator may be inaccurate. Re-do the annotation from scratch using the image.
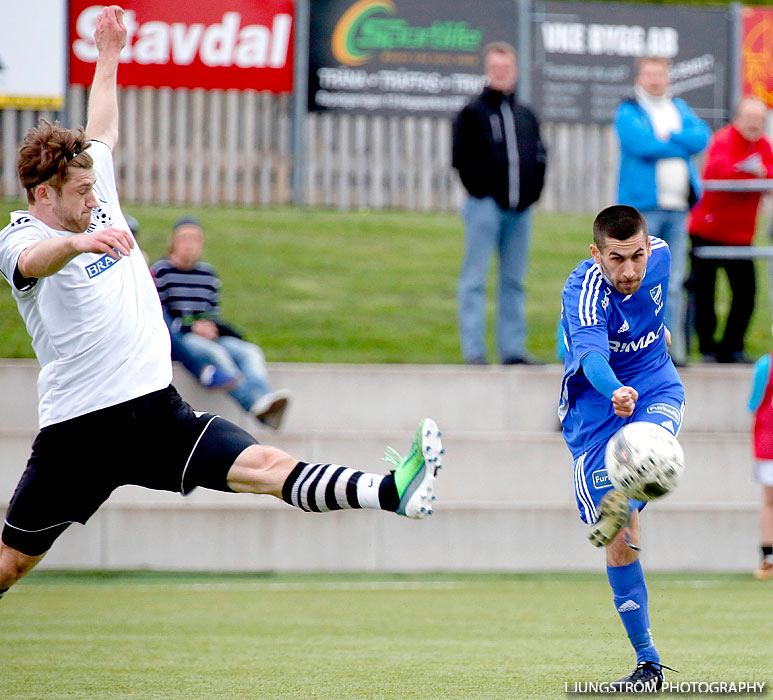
[532,2,730,127]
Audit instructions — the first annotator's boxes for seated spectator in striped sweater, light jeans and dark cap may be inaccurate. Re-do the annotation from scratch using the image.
[151,217,290,430]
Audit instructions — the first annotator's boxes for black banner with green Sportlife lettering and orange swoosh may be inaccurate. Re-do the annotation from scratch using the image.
[309,0,517,116]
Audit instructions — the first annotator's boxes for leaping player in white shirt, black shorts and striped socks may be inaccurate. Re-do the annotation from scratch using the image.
[0,6,442,595]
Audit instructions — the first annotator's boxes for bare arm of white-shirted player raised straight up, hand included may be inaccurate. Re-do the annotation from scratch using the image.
[86,5,126,149]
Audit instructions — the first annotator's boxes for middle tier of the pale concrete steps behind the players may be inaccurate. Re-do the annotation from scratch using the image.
[0,430,759,506]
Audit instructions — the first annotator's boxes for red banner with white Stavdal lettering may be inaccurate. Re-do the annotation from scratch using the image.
[70,0,295,93]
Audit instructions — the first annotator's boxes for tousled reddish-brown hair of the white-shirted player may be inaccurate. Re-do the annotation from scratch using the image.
[16,119,94,204]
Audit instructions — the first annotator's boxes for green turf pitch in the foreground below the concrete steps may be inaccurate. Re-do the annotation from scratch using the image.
[0,571,773,700]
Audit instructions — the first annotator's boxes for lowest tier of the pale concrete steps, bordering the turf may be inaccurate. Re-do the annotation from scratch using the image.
[33,503,757,571]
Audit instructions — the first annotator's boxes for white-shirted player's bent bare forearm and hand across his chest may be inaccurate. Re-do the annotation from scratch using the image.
[16,228,134,279]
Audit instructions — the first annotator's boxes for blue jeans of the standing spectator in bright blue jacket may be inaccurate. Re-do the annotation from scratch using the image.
[642,209,687,362]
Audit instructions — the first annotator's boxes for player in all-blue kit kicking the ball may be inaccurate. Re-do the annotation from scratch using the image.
[559,205,684,690]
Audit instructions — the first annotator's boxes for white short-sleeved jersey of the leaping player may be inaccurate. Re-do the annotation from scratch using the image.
[0,141,172,429]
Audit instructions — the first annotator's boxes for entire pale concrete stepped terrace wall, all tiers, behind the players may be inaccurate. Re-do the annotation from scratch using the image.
[0,360,760,571]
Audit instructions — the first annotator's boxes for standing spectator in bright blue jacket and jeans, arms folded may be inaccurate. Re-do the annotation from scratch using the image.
[615,57,711,365]
